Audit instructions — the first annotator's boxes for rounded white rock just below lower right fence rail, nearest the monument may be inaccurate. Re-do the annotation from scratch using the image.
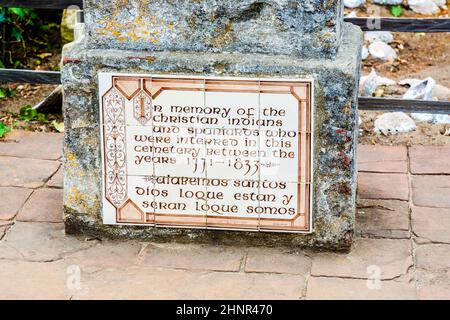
[375,112,416,135]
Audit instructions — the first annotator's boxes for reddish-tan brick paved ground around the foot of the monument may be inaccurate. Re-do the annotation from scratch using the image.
[0,132,450,299]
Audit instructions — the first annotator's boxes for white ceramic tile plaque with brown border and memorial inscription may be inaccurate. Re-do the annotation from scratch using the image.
[99,73,313,233]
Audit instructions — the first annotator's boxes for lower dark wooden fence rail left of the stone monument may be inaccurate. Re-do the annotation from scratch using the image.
[0,69,61,84]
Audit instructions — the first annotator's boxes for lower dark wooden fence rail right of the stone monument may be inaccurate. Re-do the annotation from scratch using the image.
[358,97,450,114]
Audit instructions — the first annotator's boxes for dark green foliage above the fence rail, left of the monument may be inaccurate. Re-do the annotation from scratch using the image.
[0,7,60,68]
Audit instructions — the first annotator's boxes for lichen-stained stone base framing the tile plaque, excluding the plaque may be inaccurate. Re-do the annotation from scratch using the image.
[62,24,362,249]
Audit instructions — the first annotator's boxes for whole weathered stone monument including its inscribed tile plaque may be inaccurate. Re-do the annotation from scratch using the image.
[62,0,362,250]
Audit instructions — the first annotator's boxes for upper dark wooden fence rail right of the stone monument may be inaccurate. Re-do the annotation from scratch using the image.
[345,18,450,32]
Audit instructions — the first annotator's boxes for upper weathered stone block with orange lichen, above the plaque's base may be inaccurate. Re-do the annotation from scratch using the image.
[84,0,343,58]
